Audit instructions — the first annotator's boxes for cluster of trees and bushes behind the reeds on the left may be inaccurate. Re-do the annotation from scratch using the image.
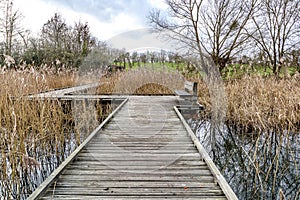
[0,0,103,69]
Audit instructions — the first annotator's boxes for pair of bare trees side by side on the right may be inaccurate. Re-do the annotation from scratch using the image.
[148,0,300,74]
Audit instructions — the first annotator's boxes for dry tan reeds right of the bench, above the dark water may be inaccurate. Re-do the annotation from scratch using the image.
[192,75,300,133]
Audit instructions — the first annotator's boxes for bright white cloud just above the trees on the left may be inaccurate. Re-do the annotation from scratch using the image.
[14,0,144,40]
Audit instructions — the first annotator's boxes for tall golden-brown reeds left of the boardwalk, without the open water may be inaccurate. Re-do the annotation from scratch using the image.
[0,70,79,199]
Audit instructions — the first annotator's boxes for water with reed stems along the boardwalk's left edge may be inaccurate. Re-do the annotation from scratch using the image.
[0,100,121,200]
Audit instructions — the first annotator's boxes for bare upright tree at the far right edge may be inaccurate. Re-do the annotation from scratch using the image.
[249,0,300,75]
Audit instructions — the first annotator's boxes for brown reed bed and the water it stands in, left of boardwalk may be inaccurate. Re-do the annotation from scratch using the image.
[0,69,111,199]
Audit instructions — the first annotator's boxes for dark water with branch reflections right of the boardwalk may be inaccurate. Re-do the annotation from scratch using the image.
[185,112,300,199]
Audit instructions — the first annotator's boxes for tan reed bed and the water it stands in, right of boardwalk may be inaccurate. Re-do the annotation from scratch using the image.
[189,75,300,199]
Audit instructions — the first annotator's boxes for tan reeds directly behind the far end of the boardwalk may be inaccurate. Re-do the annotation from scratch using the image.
[97,67,184,95]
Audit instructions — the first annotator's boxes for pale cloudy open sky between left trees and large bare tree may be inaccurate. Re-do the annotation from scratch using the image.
[14,0,166,40]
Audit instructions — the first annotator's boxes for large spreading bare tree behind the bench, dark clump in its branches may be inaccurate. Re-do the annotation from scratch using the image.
[149,0,257,70]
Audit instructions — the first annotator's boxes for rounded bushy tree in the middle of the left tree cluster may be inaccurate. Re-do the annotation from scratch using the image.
[42,13,96,68]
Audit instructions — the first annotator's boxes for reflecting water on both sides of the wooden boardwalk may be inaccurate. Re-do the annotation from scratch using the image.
[0,102,300,200]
